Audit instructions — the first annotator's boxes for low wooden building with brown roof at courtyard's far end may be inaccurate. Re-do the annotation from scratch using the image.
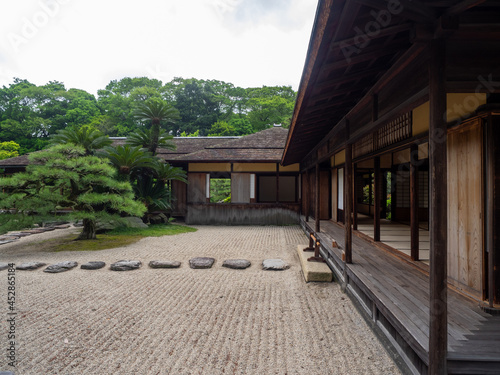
[0,126,300,225]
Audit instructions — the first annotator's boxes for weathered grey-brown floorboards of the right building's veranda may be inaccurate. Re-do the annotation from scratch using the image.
[304,220,500,373]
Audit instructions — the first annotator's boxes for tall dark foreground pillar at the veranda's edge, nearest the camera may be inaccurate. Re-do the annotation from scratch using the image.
[428,38,448,374]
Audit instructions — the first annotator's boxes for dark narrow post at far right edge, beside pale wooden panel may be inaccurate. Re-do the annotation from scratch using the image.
[484,114,498,308]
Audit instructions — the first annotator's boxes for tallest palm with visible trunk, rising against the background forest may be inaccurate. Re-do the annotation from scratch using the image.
[134,99,179,155]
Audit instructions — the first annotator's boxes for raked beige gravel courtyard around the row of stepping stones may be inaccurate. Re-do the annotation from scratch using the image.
[0,226,400,375]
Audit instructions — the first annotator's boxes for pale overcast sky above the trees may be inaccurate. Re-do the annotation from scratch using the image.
[0,0,317,94]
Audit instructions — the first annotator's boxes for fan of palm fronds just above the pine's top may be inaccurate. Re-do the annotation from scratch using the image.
[52,126,112,155]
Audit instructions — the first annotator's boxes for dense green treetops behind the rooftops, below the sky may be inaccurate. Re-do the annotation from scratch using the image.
[0,77,296,154]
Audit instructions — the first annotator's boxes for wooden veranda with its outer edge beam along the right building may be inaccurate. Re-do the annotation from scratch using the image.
[301,217,500,374]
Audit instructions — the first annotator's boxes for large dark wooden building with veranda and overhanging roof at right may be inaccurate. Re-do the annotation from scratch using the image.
[282,0,500,374]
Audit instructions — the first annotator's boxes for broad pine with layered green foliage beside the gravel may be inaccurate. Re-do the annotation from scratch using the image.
[0,144,146,240]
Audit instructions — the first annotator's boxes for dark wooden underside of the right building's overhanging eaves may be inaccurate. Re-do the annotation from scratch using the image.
[282,0,500,165]
